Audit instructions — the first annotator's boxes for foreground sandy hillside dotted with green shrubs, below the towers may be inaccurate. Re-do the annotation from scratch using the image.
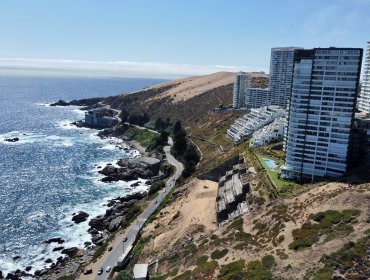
[137,179,370,279]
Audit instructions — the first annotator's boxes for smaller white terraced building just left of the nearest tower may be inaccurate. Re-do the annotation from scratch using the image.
[250,117,286,147]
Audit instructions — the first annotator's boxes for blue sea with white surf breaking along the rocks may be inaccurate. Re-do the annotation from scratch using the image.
[0,77,163,275]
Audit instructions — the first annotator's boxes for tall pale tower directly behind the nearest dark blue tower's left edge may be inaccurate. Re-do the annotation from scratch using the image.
[269,47,302,108]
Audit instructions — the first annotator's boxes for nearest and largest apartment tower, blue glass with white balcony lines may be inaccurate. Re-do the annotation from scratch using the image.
[281,48,362,181]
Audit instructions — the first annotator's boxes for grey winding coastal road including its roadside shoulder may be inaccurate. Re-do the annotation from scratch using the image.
[79,137,184,280]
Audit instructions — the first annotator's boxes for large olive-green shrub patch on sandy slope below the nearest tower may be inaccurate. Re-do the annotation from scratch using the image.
[289,209,360,250]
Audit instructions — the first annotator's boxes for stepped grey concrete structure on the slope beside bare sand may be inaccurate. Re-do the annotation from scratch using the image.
[216,159,250,223]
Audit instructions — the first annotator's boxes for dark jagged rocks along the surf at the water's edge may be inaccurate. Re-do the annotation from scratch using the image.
[0,120,164,280]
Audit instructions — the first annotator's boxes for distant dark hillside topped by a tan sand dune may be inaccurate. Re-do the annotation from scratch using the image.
[104,72,268,127]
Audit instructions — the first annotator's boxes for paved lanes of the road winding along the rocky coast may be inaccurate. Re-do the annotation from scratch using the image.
[88,137,184,280]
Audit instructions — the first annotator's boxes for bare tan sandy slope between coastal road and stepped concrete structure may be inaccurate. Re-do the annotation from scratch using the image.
[143,179,218,259]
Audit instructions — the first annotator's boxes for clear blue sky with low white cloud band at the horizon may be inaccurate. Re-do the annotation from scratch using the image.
[0,0,370,78]
